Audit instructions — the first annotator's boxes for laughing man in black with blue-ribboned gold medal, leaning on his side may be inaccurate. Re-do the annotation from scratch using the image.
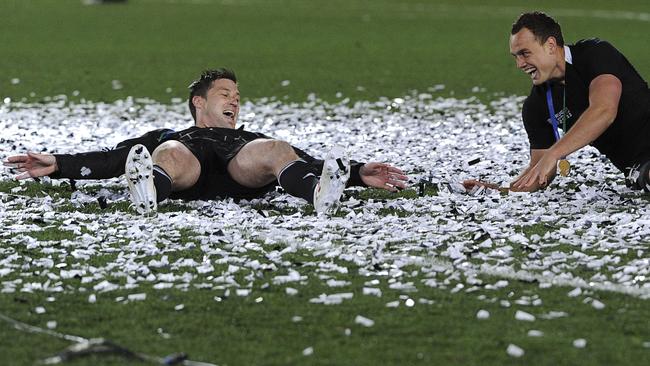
[463,12,650,192]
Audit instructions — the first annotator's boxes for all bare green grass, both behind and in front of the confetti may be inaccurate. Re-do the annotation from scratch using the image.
[0,0,650,365]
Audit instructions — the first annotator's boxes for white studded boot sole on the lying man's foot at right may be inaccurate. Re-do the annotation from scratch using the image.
[314,146,350,214]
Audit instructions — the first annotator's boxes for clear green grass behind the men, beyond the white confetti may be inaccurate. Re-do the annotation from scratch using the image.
[0,0,650,102]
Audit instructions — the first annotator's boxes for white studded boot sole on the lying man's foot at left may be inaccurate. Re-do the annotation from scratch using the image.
[124,144,158,215]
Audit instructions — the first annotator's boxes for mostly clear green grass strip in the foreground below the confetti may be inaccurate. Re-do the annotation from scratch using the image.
[0,270,650,365]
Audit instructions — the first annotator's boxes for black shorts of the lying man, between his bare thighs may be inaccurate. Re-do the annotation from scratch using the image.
[167,127,276,200]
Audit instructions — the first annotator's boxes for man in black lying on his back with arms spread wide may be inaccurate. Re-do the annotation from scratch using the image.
[5,69,407,214]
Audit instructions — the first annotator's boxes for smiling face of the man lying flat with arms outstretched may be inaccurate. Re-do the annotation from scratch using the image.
[192,79,239,128]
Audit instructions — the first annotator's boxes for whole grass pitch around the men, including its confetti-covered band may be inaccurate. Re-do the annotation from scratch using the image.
[0,0,650,365]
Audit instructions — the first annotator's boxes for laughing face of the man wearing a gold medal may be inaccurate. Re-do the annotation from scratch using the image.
[510,28,564,85]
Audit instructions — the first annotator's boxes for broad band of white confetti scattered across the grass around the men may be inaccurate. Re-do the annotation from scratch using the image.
[0,93,650,308]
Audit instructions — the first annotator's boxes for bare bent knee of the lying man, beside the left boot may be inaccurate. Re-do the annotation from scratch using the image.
[151,140,201,190]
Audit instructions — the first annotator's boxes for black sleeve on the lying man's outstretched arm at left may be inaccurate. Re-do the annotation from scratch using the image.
[50,129,173,179]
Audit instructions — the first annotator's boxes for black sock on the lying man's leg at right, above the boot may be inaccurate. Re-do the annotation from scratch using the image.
[278,160,318,204]
